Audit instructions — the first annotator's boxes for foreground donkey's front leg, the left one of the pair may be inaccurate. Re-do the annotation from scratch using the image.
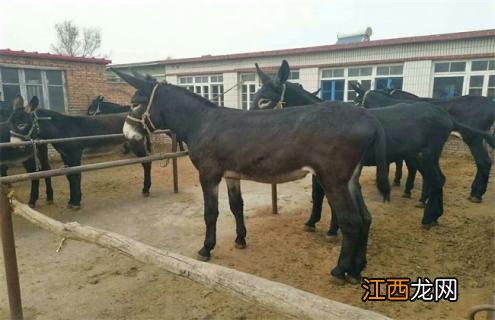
[198,174,221,261]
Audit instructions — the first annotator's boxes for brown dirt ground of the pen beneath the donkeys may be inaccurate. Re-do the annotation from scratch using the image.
[0,147,495,319]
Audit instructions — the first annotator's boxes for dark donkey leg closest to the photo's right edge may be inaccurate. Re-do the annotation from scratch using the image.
[468,139,492,203]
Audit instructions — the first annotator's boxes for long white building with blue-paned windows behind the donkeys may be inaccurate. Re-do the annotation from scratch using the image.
[108,29,495,109]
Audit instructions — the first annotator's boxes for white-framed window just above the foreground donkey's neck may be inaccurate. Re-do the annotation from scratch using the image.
[178,74,224,106]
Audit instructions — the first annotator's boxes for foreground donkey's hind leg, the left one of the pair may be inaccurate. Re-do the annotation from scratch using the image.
[325,183,363,282]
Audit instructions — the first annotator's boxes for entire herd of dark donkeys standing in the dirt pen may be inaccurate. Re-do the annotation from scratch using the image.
[0,60,495,284]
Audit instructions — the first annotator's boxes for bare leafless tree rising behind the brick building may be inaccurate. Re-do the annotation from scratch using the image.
[51,20,101,57]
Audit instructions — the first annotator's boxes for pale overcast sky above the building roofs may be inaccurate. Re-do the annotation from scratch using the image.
[0,0,495,63]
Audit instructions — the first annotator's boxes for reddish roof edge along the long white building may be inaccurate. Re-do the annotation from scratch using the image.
[113,29,495,67]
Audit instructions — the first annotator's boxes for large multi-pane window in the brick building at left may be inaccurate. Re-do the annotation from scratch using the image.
[0,67,66,112]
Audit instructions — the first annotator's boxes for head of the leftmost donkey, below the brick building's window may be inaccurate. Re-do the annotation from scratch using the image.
[9,96,39,142]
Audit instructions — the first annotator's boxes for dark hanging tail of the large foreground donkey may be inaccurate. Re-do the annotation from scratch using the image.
[374,125,390,202]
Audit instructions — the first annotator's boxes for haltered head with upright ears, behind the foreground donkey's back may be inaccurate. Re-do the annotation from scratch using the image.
[251,60,290,110]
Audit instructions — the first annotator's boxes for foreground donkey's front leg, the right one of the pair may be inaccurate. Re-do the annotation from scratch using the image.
[225,179,246,249]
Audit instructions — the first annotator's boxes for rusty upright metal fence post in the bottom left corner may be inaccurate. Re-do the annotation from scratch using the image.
[0,184,24,320]
